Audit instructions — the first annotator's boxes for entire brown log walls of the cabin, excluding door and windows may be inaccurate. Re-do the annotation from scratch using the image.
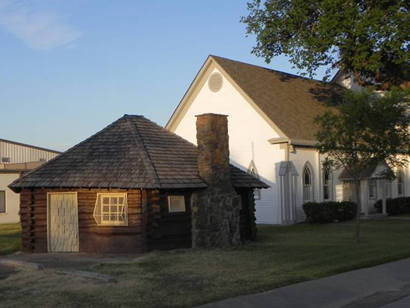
[20,189,256,253]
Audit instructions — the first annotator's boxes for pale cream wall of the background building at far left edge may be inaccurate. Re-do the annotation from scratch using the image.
[0,173,20,224]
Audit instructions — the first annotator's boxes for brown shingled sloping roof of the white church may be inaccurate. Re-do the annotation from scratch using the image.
[210,56,343,140]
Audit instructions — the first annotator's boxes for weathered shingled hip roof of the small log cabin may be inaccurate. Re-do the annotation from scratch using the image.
[9,115,268,191]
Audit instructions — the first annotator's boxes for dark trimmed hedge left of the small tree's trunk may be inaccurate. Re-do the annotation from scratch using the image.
[303,201,357,223]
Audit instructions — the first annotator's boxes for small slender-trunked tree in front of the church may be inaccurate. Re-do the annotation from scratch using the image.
[316,90,410,241]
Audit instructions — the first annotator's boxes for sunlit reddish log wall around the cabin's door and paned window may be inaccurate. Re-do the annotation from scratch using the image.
[20,189,146,253]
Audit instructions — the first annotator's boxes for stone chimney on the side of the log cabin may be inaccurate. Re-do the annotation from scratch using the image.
[191,113,241,247]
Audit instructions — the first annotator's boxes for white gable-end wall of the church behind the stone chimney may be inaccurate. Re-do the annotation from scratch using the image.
[174,68,285,224]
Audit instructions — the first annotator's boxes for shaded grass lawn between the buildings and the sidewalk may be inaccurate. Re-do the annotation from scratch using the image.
[0,219,410,307]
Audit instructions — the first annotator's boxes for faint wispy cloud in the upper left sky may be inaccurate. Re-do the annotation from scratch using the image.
[0,0,81,50]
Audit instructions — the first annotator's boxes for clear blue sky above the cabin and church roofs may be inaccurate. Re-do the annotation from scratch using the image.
[0,0,328,150]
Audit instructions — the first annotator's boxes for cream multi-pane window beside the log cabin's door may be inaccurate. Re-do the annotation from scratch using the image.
[94,193,128,226]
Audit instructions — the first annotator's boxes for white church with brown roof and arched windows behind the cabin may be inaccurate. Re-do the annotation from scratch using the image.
[166,56,410,224]
